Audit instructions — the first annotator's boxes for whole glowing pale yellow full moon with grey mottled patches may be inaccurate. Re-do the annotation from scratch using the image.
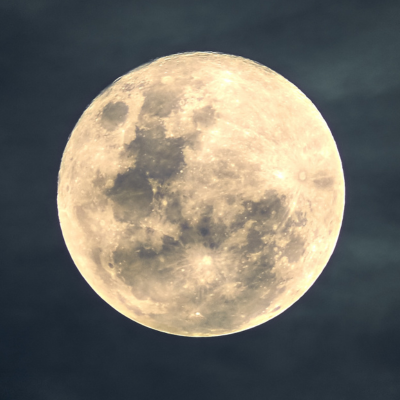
[58,52,344,337]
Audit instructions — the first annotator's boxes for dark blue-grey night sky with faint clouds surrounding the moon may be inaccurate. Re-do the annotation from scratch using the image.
[0,0,400,400]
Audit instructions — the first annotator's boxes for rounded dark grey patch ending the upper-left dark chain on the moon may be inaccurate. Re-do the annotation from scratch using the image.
[105,169,153,222]
